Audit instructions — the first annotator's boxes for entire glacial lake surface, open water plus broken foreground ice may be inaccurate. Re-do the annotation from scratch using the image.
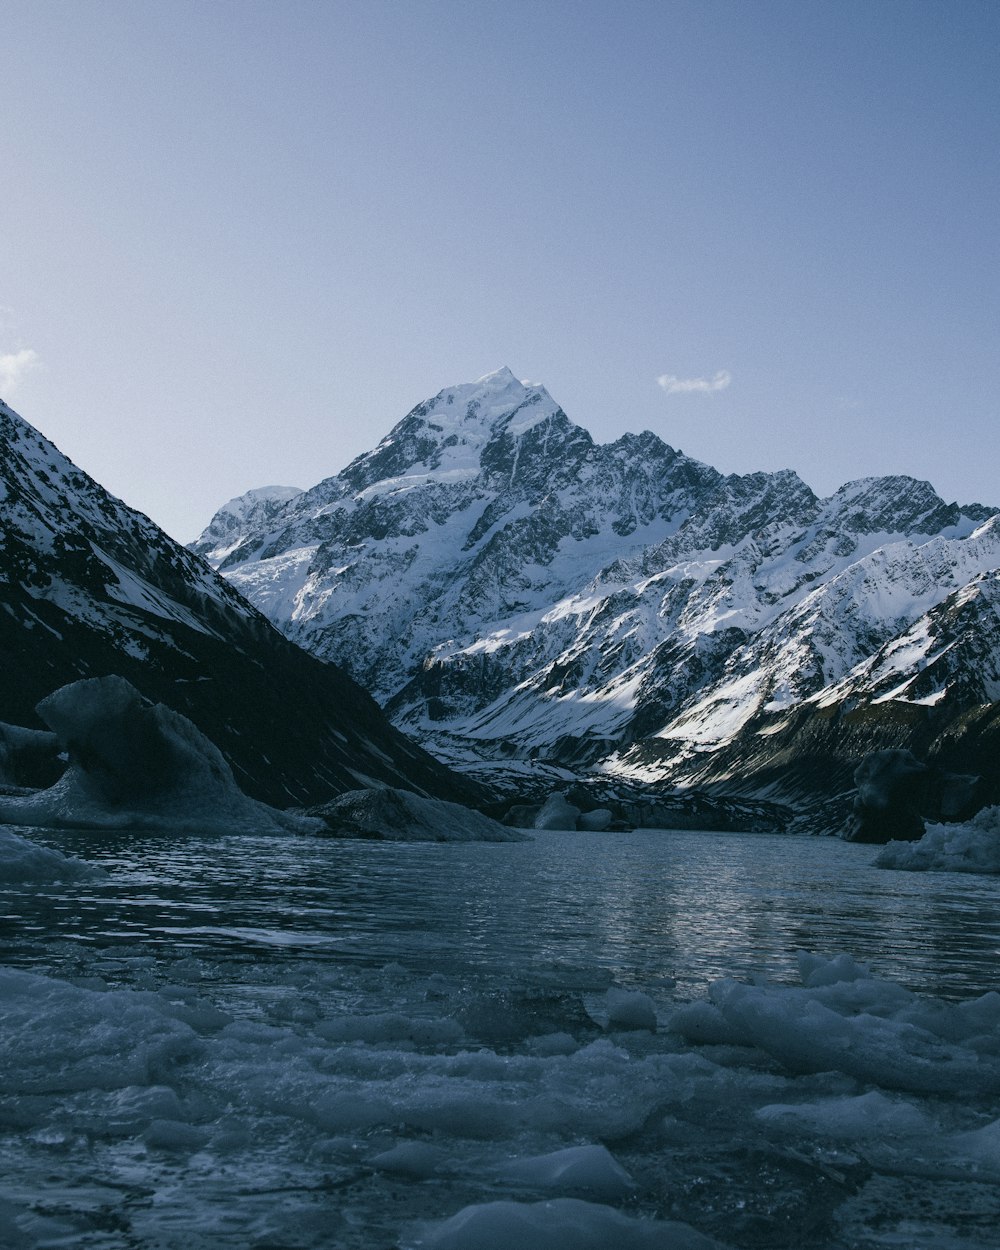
[0,830,1000,1250]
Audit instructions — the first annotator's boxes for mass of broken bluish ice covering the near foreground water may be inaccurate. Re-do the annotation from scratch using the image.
[0,930,1000,1250]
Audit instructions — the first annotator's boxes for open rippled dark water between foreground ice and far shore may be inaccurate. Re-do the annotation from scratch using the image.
[0,830,1000,998]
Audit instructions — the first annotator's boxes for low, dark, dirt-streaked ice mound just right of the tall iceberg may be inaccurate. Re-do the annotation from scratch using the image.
[309,786,528,843]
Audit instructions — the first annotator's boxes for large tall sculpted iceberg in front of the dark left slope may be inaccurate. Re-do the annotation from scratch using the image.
[0,676,320,833]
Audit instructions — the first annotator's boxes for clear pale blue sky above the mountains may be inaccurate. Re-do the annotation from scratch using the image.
[0,0,1000,540]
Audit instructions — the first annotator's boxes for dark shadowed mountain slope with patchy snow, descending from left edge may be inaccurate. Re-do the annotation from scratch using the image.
[0,403,469,806]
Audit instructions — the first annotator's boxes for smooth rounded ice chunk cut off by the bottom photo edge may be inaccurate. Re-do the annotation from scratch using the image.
[401,1198,720,1250]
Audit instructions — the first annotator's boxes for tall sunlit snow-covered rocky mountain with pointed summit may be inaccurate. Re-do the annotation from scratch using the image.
[195,370,1000,793]
